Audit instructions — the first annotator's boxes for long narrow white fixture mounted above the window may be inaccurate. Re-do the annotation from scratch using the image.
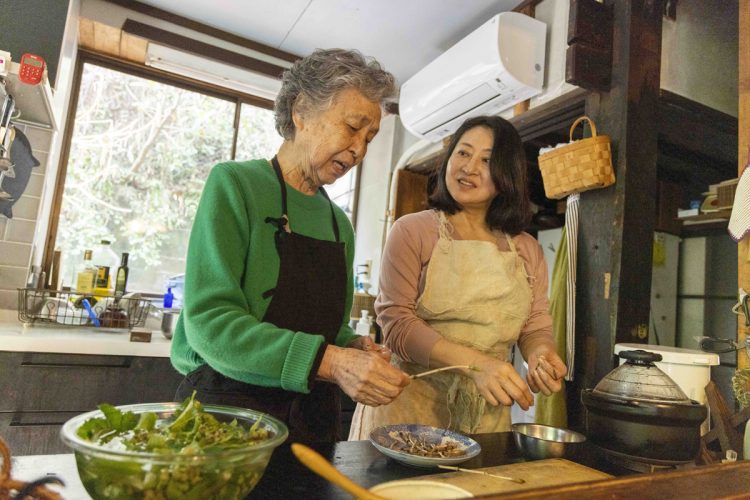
[146,43,281,101]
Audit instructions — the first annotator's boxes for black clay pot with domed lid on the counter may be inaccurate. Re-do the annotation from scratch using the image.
[581,351,707,465]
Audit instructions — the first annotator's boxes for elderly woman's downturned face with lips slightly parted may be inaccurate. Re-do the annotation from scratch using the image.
[293,89,380,188]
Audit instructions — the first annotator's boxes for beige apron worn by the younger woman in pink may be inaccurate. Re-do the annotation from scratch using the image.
[349,212,533,440]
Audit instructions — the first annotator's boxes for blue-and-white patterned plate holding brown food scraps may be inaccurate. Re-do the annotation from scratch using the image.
[370,424,482,467]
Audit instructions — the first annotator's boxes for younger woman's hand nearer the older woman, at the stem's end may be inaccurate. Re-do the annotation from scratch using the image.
[468,354,534,410]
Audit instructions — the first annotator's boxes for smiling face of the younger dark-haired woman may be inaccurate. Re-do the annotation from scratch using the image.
[445,126,497,210]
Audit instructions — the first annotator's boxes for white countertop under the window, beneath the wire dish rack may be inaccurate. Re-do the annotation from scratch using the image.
[0,315,170,358]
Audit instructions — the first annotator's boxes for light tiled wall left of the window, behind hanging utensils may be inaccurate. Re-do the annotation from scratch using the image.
[0,125,52,309]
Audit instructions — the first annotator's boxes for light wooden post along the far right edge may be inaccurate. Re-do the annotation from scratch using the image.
[737,0,750,372]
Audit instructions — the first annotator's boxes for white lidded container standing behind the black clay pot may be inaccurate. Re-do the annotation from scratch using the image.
[615,344,719,435]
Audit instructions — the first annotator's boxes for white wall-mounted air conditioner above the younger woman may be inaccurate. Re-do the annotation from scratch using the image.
[399,12,547,141]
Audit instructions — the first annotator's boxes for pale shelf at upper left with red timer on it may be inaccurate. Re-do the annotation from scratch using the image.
[0,62,57,130]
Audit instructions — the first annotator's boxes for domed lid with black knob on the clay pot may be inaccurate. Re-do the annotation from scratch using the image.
[593,350,691,404]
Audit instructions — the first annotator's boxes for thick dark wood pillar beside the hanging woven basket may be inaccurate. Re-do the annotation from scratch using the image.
[568,0,663,427]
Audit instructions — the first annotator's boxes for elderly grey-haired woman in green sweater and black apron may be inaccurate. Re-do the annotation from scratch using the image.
[171,49,409,442]
